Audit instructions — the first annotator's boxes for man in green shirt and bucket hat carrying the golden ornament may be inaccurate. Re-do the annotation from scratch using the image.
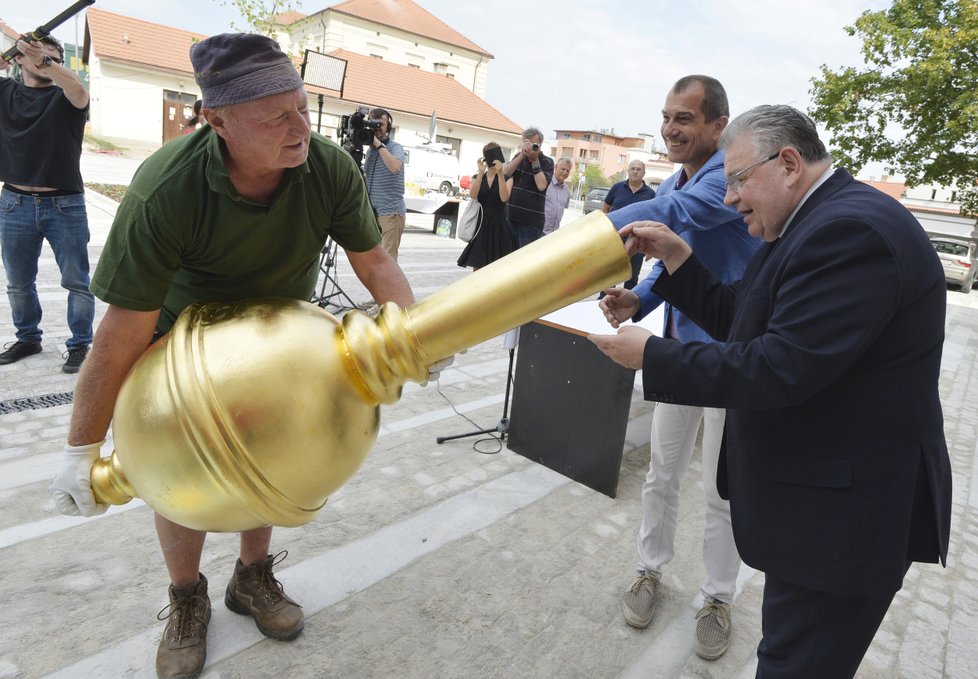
[51,34,414,677]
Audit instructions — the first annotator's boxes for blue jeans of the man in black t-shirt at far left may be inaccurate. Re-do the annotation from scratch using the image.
[0,189,95,349]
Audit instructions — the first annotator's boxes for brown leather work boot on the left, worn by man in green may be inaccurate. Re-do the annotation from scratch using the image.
[156,574,211,679]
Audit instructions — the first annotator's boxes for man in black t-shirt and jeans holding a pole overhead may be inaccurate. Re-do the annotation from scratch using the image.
[0,36,95,373]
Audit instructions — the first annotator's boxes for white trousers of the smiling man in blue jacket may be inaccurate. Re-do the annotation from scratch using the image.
[638,403,740,603]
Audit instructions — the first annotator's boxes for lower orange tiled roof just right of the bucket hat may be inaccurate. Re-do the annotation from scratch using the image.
[308,50,522,134]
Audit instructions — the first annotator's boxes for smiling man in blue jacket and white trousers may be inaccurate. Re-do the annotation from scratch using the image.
[599,75,760,660]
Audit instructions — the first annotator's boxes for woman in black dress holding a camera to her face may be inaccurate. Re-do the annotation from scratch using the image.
[458,141,516,269]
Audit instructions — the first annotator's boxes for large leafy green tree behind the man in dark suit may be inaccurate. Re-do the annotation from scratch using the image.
[809,0,978,214]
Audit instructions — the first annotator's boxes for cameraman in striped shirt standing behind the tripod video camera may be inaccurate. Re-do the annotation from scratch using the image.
[364,108,406,260]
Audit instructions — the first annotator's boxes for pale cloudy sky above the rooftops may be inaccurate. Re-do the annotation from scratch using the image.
[0,0,890,175]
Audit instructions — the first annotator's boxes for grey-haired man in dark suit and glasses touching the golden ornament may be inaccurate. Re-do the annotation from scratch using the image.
[591,106,951,679]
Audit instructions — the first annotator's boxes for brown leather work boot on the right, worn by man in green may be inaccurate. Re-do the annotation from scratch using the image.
[224,552,306,641]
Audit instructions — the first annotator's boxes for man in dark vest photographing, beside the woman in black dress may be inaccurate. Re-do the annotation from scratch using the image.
[504,127,554,248]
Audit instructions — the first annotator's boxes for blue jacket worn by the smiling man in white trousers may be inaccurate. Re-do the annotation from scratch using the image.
[608,151,762,342]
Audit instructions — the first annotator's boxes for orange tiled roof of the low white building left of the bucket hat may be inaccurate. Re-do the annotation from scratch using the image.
[84,7,207,75]
